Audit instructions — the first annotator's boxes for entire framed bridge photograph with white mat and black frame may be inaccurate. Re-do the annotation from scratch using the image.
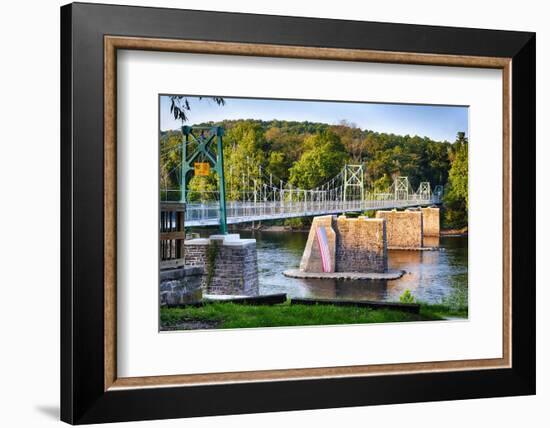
[61,3,535,424]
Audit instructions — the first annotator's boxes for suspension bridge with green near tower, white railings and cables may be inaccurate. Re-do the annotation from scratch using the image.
[161,126,443,229]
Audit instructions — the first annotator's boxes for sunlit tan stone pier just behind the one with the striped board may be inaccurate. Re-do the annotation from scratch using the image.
[376,210,424,249]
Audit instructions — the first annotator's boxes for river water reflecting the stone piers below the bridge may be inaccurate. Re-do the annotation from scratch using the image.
[240,232,468,304]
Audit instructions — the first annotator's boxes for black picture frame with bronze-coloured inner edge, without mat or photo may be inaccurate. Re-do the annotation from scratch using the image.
[61,3,536,424]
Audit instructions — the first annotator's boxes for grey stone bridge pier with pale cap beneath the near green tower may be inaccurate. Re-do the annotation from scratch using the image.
[185,235,259,296]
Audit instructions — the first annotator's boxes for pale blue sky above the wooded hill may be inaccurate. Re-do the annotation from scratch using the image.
[160,96,468,142]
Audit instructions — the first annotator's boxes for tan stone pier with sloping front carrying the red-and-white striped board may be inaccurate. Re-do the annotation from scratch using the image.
[300,216,388,272]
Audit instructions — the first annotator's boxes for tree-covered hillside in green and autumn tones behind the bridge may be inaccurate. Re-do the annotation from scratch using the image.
[160,120,468,228]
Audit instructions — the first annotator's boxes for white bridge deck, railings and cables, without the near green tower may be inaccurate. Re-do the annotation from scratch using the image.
[161,165,443,227]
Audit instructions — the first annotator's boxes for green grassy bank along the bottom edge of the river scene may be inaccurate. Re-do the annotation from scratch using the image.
[160,302,468,330]
